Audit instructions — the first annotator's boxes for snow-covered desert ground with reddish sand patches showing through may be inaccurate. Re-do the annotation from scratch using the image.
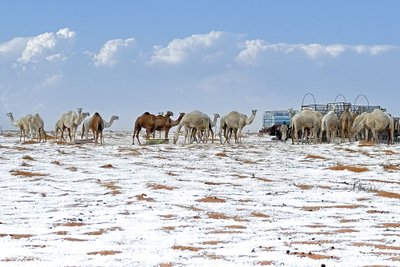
[0,132,400,266]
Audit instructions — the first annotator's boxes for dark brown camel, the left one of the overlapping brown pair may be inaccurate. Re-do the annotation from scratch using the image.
[132,111,174,145]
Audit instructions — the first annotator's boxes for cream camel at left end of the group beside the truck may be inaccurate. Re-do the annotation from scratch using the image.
[290,109,322,144]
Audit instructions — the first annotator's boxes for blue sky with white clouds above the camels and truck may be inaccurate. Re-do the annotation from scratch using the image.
[0,0,400,130]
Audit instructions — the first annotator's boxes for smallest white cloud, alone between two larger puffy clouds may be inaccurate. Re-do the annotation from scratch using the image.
[93,38,135,67]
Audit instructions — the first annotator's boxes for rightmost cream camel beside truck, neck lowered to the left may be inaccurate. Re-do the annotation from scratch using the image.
[351,109,394,144]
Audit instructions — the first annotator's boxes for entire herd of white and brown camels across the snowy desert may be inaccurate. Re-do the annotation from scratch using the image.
[7,108,394,147]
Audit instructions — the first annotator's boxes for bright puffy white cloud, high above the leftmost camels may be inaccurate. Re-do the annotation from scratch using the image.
[17,28,76,64]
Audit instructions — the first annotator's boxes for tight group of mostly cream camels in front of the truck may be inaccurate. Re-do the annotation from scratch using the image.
[290,108,394,144]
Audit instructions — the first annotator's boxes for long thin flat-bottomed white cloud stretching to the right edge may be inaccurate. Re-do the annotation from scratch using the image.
[236,40,400,64]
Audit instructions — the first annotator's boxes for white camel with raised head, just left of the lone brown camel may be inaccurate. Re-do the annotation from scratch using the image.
[55,108,90,142]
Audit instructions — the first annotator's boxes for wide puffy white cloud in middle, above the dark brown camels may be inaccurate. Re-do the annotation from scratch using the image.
[150,31,236,64]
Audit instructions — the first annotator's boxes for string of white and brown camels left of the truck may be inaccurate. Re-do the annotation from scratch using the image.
[7,108,257,147]
